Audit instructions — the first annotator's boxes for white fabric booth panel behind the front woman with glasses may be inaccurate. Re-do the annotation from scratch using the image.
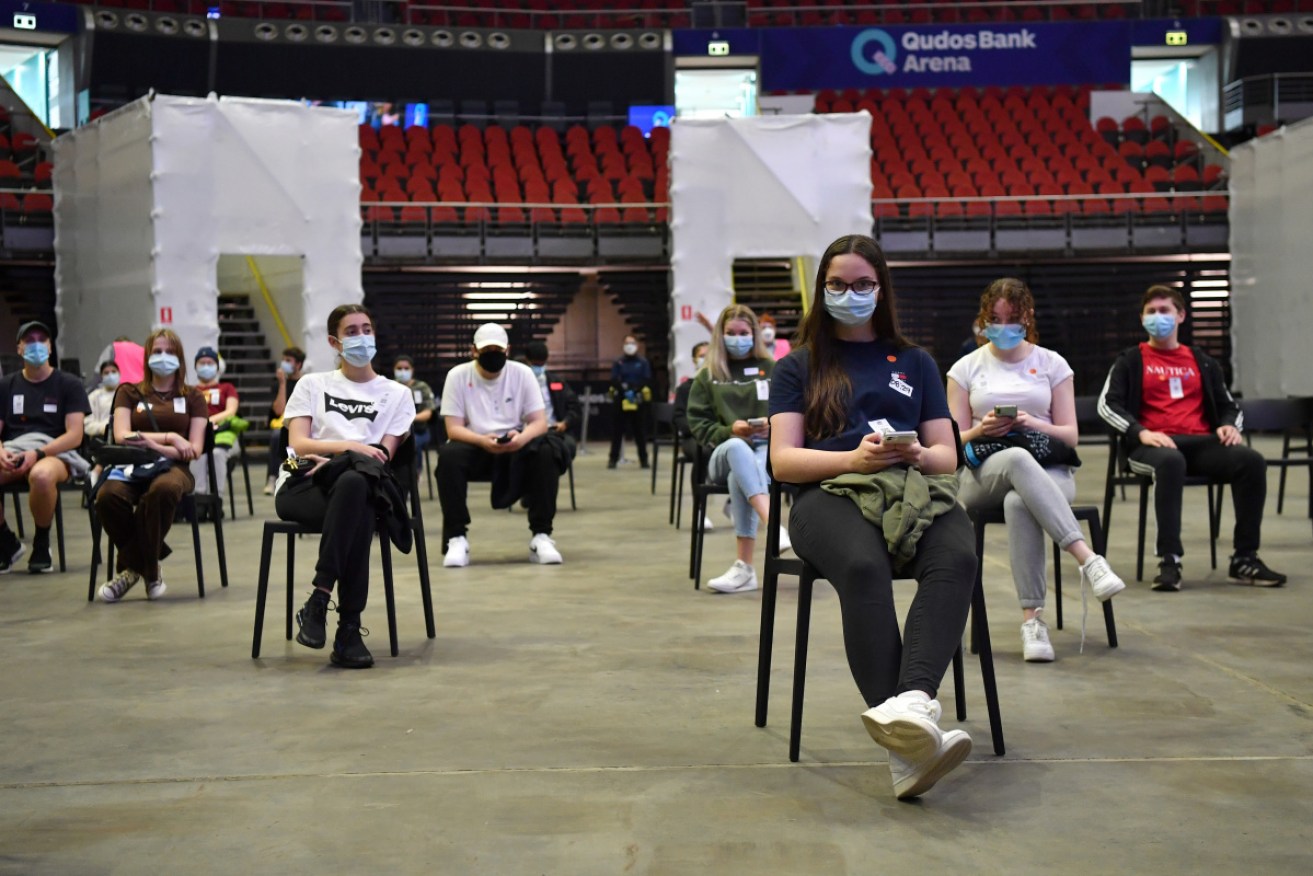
[670,112,872,381]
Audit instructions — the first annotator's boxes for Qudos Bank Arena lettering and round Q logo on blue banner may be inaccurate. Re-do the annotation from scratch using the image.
[851,28,1039,76]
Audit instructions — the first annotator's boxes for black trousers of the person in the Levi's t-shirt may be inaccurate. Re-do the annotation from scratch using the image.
[274,471,377,617]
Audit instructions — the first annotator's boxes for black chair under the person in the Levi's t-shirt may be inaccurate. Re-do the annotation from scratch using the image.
[251,436,437,659]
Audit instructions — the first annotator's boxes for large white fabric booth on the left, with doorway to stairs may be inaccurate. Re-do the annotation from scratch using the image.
[54,95,364,368]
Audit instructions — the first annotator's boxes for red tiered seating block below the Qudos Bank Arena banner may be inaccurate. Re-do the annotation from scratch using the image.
[815,87,1225,218]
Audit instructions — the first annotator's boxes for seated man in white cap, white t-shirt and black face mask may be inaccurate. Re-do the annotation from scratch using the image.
[437,323,570,567]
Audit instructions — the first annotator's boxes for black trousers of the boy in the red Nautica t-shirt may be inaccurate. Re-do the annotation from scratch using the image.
[1130,435,1267,557]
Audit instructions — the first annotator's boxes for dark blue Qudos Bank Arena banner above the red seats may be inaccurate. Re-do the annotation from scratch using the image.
[759,21,1132,91]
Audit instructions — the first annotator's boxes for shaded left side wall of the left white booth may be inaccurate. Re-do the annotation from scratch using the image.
[54,100,155,372]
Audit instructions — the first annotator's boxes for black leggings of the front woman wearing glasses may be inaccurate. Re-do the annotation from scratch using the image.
[789,487,976,705]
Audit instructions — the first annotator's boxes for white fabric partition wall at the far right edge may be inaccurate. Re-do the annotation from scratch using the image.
[1229,121,1313,398]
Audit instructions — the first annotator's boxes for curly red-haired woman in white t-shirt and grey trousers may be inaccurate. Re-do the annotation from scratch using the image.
[948,277,1125,662]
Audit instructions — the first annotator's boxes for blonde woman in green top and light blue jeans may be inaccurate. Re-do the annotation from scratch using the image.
[688,305,789,594]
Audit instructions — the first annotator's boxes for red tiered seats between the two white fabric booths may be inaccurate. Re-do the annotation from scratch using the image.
[360,125,670,225]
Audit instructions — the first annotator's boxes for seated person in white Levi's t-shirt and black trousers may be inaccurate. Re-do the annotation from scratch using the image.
[274,305,415,668]
